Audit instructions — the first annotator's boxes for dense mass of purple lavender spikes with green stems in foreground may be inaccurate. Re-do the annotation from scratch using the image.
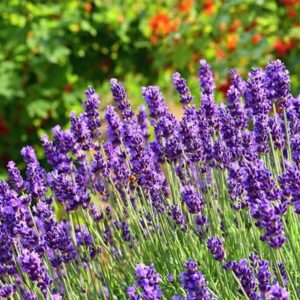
[0,60,300,300]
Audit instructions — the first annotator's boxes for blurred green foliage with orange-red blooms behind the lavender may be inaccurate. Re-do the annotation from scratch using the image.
[0,0,300,176]
